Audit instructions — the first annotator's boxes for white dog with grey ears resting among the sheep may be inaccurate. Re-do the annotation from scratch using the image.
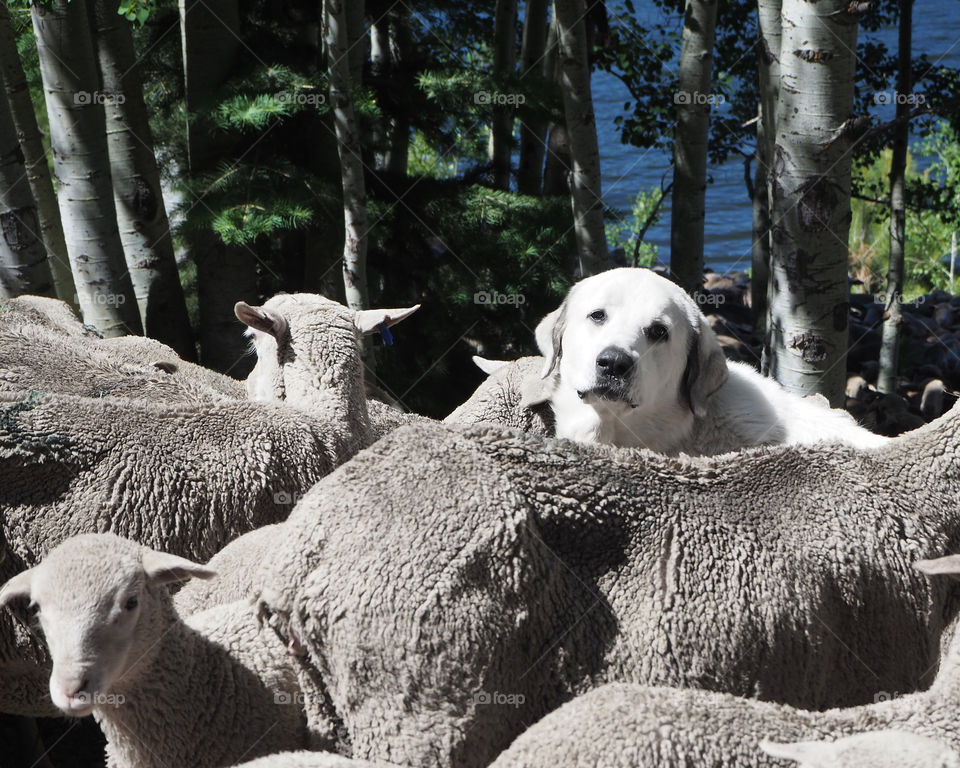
[536,268,888,455]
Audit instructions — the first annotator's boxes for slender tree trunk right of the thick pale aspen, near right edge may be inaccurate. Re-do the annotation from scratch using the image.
[877,0,913,393]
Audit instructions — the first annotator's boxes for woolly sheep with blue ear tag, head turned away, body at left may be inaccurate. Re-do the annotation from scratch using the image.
[0,296,420,714]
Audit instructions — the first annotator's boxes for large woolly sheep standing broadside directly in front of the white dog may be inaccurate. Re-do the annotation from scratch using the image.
[252,408,960,766]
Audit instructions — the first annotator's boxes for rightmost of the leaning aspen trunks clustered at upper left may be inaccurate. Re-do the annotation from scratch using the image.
[93,0,196,360]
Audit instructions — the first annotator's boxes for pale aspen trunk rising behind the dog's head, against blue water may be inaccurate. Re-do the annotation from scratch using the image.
[670,0,717,295]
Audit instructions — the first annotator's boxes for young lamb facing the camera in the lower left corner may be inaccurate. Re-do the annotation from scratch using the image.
[0,534,320,768]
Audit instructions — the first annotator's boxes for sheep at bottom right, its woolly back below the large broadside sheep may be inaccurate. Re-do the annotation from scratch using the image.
[491,555,960,768]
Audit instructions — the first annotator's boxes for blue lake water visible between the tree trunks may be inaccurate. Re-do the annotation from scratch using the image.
[593,0,960,272]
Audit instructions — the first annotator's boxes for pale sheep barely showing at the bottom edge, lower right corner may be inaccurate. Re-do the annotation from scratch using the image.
[760,731,960,768]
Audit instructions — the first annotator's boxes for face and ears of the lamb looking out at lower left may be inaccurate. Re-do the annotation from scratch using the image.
[0,534,212,717]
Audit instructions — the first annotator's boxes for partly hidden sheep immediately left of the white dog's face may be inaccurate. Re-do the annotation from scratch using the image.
[443,357,553,435]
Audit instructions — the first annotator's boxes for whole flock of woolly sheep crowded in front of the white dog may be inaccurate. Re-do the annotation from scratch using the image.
[0,282,960,768]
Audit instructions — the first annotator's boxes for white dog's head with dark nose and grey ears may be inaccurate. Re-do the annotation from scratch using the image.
[536,268,727,416]
